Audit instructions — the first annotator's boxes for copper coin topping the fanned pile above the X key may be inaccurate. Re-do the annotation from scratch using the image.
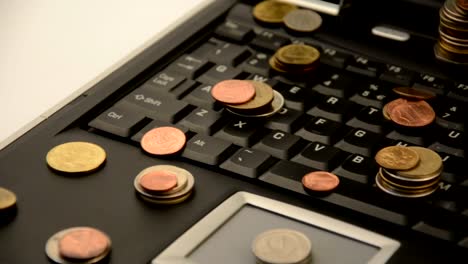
[211,80,255,104]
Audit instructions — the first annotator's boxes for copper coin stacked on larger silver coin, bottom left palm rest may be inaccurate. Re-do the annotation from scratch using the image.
[45,227,111,264]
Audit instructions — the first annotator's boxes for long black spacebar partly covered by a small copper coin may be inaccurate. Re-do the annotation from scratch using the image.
[259,172,409,226]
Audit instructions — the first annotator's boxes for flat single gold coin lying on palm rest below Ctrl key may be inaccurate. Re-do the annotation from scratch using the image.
[46,142,106,173]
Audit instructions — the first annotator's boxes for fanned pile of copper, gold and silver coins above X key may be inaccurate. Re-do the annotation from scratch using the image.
[211,80,284,117]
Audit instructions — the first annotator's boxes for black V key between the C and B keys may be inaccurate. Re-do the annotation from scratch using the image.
[291,142,344,171]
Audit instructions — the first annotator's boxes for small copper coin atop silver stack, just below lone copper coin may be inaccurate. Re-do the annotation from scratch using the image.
[140,170,177,192]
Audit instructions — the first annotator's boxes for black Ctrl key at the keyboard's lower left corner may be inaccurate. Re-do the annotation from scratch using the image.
[88,106,145,137]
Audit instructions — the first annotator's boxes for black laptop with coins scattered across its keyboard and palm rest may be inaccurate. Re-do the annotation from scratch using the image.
[0,0,468,264]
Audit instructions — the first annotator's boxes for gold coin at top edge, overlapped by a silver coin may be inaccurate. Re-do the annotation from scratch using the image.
[253,0,297,24]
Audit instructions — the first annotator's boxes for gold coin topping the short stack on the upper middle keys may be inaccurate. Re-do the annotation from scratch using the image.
[275,44,320,66]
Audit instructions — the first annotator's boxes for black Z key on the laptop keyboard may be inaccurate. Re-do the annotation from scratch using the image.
[179,107,225,135]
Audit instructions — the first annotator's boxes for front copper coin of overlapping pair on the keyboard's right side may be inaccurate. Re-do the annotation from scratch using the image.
[387,99,435,127]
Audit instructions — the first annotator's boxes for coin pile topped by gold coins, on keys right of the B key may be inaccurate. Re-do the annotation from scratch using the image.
[375,146,443,198]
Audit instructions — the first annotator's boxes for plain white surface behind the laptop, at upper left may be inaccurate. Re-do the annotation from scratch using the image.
[0,0,214,149]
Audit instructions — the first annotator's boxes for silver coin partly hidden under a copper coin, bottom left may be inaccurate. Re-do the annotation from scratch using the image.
[45,227,111,264]
